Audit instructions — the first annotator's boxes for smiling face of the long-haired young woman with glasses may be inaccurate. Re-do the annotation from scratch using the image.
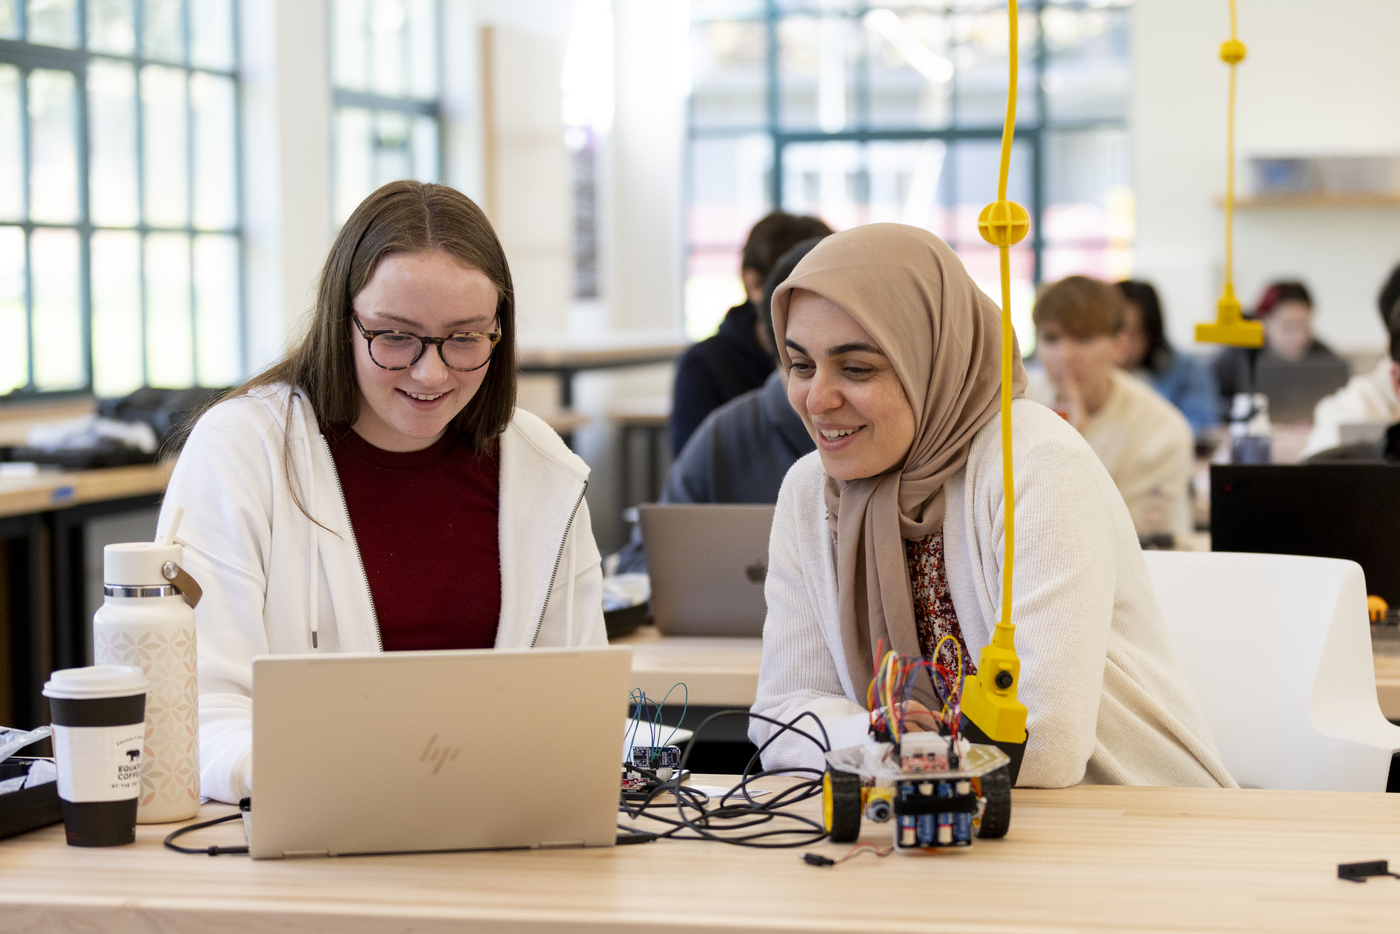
[346,251,497,451]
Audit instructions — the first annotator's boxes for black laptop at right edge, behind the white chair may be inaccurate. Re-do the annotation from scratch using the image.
[1211,463,1400,606]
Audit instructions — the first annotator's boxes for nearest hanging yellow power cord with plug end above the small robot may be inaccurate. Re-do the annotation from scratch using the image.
[962,0,1030,761]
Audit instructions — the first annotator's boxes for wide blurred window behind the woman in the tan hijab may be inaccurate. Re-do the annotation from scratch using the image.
[686,0,1133,350]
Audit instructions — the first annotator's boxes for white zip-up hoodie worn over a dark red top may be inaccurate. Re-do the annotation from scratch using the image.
[160,385,608,802]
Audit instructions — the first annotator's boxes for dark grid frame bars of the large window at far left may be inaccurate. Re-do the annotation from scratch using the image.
[0,0,248,405]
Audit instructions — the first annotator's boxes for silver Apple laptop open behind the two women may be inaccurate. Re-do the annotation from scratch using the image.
[641,503,773,636]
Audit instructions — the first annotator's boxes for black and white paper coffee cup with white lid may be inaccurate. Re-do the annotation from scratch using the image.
[43,665,148,846]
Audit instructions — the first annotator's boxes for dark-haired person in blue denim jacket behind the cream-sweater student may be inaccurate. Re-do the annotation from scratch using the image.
[1114,280,1219,437]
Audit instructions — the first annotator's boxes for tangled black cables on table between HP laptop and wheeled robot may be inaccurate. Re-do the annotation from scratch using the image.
[619,710,832,849]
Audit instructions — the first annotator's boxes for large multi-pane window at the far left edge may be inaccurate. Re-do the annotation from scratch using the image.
[0,0,244,396]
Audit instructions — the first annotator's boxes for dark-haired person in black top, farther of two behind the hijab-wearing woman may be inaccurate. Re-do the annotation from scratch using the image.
[671,211,832,456]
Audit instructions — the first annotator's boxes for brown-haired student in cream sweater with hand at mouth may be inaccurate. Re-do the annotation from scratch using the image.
[1026,276,1196,546]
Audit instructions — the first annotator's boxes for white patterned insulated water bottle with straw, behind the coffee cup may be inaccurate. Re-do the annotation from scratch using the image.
[92,511,200,823]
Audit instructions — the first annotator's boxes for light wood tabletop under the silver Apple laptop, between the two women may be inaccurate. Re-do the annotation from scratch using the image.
[609,626,763,707]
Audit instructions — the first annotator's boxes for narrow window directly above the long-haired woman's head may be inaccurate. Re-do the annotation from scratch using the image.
[329,0,441,223]
